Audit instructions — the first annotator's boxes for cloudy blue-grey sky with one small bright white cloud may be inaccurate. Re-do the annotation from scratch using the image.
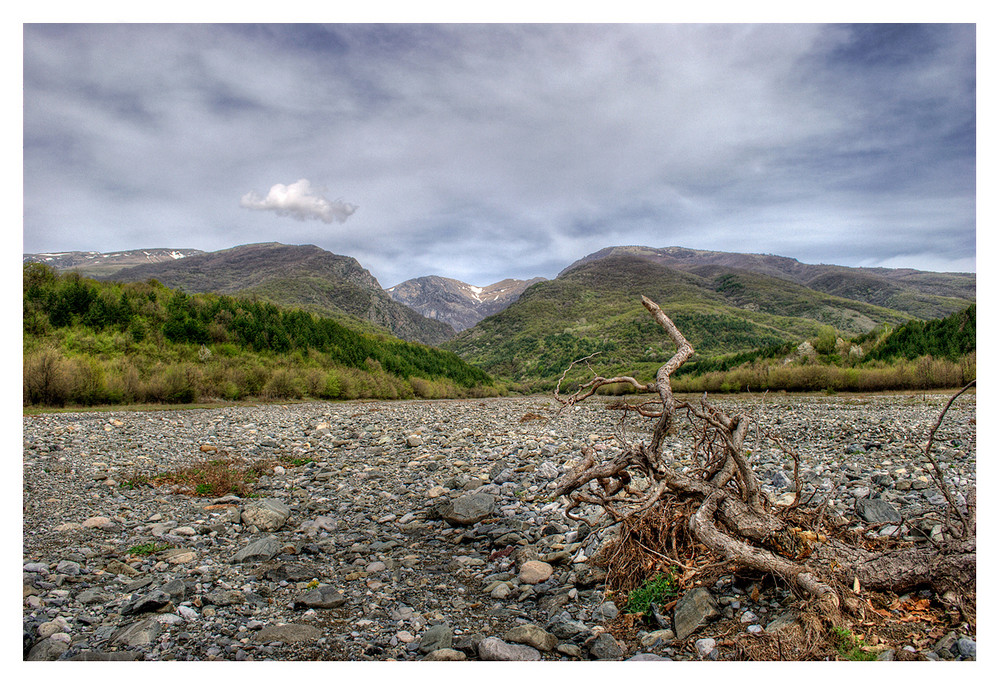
[23,24,976,287]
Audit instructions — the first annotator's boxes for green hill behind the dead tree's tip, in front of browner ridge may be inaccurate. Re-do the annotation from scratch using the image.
[444,257,928,390]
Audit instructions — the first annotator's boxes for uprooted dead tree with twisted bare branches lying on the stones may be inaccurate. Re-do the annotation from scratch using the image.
[555,297,976,616]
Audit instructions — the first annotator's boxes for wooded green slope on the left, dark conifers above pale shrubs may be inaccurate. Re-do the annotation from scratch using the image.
[23,264,501,406]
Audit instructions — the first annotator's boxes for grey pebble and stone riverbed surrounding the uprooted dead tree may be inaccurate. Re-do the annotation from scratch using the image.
[23,394,976,661]
